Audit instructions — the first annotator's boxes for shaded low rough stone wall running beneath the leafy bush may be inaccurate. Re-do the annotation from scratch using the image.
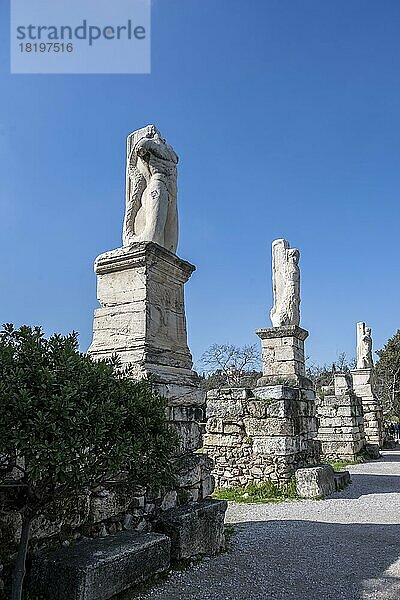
[0,453,214,589]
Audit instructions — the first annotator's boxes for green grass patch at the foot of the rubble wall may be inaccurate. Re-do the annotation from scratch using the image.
[213,477,299,504]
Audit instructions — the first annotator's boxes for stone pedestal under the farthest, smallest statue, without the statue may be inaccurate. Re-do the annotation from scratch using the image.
[351,369,384,448]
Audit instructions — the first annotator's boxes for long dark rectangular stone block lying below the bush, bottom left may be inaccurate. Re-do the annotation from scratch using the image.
[32,531,170,600]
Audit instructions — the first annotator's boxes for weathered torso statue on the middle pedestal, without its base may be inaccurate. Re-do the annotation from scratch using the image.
[270,240,300,327]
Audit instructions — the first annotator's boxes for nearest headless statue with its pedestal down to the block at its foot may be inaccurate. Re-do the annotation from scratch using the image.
[89,125,226,559]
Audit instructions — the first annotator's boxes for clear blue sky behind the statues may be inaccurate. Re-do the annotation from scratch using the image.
[0,0,400,362]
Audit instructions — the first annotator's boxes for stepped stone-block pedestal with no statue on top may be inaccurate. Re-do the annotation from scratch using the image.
[317,373,365,460]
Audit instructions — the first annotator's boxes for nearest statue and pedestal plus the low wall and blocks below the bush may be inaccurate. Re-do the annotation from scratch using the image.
[9,125,227,600]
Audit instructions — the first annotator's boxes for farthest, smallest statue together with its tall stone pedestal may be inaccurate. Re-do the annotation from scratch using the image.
[351,322,384,448]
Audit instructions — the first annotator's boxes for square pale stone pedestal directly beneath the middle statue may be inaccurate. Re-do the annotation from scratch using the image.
[256,325,312,389]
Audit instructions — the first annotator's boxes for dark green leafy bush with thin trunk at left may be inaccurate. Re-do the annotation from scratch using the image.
[0,325,177,600]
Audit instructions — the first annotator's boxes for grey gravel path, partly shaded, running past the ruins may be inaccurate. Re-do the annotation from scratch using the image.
[139,450,400,600]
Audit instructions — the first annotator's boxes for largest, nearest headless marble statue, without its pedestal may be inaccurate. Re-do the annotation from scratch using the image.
[123,125,179,253]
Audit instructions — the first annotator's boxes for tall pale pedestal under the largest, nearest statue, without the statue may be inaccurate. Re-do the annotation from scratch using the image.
[89,242,205,466]
